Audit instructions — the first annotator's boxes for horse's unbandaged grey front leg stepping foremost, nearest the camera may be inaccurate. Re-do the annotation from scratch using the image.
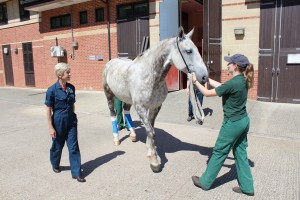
[135,105,161,172]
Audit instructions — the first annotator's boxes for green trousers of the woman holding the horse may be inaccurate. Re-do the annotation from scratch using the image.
[199,116,254,193]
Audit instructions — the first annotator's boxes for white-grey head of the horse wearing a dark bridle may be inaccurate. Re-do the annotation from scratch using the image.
[171,28,208,84]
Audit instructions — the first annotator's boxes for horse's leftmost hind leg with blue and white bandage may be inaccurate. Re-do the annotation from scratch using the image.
[104,84,120,146]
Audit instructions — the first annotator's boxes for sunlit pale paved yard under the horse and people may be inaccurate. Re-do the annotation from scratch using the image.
[0,87,300,200]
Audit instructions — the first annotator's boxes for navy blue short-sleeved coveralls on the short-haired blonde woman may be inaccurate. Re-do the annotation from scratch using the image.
[45,81,81,176]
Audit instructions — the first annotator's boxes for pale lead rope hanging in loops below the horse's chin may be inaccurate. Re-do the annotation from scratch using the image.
[188,74,204,125]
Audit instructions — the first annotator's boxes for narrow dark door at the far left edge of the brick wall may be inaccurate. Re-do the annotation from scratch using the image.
[2,45,14,86]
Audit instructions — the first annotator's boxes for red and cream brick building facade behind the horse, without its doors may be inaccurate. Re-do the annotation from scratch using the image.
[0,0,300,102]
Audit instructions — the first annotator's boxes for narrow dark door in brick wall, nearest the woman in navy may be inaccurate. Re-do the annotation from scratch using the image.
[22,42,35,86]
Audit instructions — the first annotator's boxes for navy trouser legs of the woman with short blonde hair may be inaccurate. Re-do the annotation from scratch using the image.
[50,115,81,176]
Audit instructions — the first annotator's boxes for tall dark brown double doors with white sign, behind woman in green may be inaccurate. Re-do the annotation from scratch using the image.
[258,0,300,103]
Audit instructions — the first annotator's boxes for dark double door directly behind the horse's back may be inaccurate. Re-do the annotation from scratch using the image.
[117,2,149,59]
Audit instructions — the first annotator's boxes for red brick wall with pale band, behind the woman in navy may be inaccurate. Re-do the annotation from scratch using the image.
[0,0,139,90]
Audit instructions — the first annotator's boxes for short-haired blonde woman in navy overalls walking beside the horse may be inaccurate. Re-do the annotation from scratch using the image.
[45,63,85,182]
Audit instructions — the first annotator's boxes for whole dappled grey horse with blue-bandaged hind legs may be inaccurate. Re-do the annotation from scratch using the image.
[102,28,208,172]
